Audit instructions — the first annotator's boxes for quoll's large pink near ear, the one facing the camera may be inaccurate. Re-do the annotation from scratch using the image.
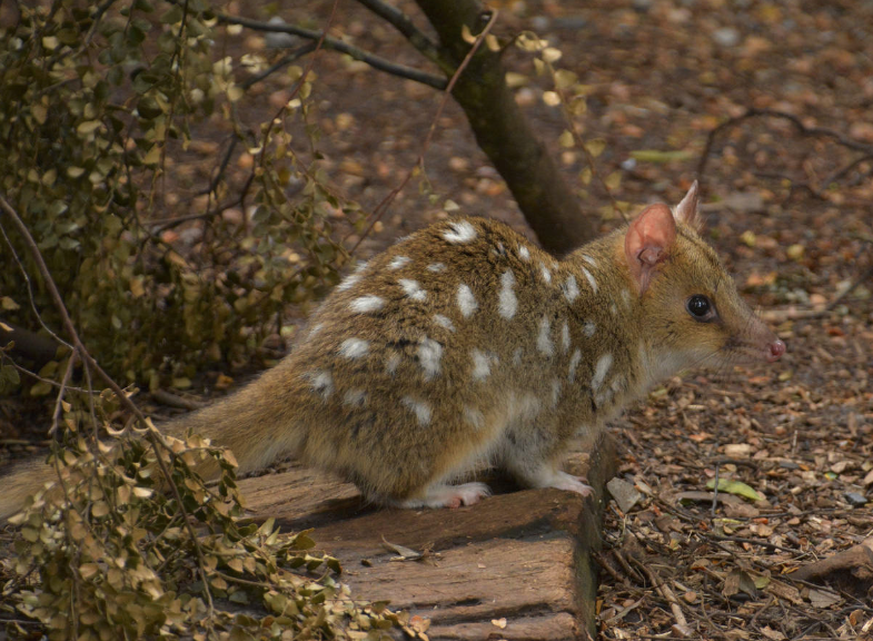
[624,203,676,294]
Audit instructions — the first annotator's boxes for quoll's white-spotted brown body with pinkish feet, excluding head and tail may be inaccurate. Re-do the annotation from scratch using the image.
[293,219,630,505]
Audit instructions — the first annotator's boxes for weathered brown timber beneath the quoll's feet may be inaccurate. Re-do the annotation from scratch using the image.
[240,430,614,641]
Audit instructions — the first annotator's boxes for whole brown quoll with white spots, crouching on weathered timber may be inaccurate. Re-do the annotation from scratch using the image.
[0,183,785,513]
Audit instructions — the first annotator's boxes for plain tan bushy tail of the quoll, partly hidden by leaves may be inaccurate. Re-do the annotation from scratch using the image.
[0,364,304,522]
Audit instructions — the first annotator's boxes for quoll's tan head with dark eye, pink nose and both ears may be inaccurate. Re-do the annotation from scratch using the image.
[624,182,785,369]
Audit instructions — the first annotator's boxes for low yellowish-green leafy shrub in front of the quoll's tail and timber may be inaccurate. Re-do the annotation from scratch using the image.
[2,395,402,641]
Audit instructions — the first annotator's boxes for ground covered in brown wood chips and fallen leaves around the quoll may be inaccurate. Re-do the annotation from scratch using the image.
[1,0,873,641]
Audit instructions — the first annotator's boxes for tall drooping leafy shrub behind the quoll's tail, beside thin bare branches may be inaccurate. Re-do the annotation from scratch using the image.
[0,0,357,394]
